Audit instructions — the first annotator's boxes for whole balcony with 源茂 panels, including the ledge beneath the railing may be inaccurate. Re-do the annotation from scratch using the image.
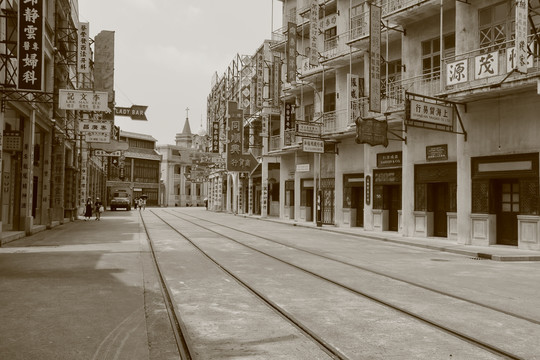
[443,37,540,98]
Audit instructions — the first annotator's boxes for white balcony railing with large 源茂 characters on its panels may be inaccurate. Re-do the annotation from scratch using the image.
[443,35,540,92]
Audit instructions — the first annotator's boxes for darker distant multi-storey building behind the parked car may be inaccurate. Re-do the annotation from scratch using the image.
[107,131,161,206]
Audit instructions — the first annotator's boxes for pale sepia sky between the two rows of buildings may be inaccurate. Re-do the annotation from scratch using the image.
[79,0,282,144]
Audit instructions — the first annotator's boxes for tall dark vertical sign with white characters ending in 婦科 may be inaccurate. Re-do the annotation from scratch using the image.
[18,0,43,91]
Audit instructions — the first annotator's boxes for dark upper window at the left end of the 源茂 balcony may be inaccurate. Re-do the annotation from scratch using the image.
[422,33,456,79]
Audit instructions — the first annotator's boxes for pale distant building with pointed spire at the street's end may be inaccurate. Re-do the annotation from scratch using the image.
[158,117,216,206]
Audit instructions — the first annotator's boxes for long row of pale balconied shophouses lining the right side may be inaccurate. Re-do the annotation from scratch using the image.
[208,0,540,250]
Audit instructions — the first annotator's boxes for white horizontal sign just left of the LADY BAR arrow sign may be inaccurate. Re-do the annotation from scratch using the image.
[58,89,109,111]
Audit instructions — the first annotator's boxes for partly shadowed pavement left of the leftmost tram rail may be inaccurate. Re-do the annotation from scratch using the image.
[0,211,177,360]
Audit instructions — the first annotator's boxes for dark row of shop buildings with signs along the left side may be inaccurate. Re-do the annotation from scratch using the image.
[0,0,105,234]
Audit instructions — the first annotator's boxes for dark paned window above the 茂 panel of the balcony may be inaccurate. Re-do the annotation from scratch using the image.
[478,1,515,51]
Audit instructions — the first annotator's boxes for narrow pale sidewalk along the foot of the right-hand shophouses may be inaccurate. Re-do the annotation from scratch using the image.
[237,214,540,261]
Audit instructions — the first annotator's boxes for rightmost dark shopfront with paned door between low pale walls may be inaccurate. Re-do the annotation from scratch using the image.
[471,153,540,246]
